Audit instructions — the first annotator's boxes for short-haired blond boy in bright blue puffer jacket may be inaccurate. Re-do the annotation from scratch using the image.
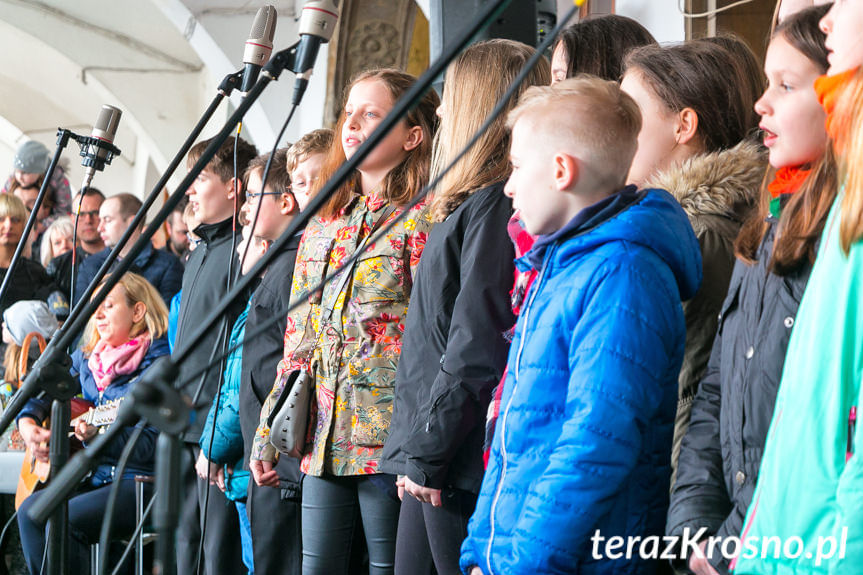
[461,77,701,575]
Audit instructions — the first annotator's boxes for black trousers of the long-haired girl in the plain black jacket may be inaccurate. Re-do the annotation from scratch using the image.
[395,489,477,575]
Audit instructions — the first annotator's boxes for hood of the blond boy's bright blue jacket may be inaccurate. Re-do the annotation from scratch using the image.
[518,186,701,300]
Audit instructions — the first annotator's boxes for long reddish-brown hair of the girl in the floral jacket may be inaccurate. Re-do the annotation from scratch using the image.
[312,68,440,218]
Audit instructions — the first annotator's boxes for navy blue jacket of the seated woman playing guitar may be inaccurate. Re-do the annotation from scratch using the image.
[18,337,168,486]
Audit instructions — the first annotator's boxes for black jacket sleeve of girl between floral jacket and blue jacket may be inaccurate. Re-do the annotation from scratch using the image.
[404,194,515,489]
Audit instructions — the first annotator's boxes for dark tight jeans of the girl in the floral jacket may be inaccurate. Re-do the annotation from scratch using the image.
[302,475,400,575]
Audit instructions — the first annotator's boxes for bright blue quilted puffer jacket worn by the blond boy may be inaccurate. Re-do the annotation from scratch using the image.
[461,187,701,575]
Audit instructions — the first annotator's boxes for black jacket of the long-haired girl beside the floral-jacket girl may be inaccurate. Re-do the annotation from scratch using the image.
[380,183,515,493]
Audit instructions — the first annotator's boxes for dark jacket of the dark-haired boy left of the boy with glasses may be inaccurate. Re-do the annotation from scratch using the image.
[174,219,247,445]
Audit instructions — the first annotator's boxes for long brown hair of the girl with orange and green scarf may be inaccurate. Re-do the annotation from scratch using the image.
[734,5,838,276]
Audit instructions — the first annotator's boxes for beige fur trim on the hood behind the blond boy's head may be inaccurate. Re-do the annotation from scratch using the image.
[644,141,767,235]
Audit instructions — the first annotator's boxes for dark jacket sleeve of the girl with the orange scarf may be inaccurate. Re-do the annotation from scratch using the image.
[666,324,731,535]
